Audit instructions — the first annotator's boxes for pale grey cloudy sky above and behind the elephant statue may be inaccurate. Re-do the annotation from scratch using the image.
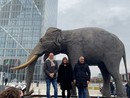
[58,0,130,76]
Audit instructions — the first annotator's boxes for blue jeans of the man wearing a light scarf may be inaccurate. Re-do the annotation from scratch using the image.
[46,79,58,98]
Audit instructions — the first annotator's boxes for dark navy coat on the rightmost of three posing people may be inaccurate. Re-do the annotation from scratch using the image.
[74,62,91,87]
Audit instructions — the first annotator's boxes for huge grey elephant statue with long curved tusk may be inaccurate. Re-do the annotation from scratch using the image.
[12,27,128,98]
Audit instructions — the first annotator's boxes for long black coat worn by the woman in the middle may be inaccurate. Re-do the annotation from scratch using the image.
[57,64,73,90]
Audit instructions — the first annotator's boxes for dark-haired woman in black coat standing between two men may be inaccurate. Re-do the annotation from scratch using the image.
[57,57,73,98]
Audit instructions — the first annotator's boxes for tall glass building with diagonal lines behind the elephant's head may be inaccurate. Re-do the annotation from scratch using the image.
[0,0,58,81]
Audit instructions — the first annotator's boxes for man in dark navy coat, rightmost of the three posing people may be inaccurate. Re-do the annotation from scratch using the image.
[74,56,91,98]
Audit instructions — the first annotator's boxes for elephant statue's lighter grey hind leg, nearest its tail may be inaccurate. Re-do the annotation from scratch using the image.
[105,56,127,98]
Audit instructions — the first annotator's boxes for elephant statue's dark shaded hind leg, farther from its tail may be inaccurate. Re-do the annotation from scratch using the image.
[98,62,111,97]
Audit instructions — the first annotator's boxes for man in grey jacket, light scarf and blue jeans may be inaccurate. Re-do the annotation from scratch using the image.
[44,53,58,98]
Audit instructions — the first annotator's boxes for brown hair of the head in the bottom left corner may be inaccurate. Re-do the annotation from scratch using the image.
[0,87,20,98]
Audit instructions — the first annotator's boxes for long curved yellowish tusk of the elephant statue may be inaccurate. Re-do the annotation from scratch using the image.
[11,55,38,70]
